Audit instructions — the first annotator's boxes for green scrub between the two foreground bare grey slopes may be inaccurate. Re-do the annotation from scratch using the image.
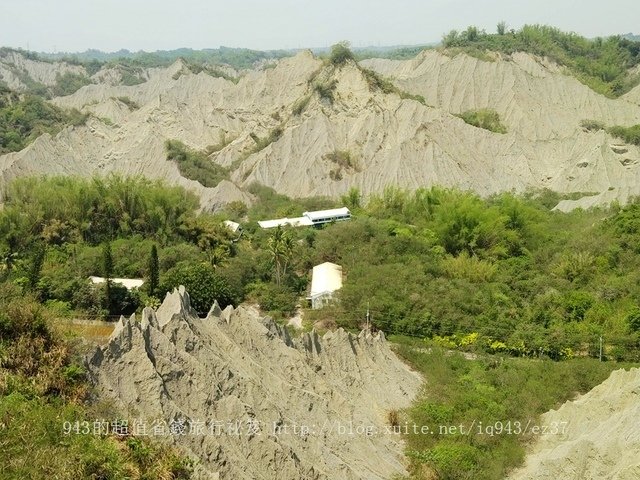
[390,337,622,480]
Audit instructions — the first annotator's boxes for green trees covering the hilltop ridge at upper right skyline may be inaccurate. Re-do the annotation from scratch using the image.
[442,23,640,97]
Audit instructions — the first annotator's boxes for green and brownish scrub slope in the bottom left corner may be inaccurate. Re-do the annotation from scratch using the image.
[0,283,192,480]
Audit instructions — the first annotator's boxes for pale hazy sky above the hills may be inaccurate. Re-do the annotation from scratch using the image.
[0,0,640,52]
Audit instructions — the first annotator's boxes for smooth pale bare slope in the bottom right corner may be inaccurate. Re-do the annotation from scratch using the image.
[509,368,640,480]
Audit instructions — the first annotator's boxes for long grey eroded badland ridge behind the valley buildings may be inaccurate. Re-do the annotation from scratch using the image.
[0,50,640,209]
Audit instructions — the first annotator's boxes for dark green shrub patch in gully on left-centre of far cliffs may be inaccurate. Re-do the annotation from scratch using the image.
[165,140,229,187]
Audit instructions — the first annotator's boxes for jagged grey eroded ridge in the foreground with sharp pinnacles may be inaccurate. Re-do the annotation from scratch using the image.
[87,289,421,480]
